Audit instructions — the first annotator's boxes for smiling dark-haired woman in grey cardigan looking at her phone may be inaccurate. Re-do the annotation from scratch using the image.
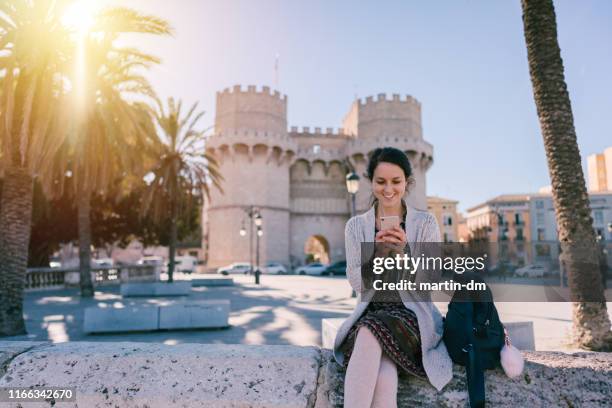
[334,147,452,408]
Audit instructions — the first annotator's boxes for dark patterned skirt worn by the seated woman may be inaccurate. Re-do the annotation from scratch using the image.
[342,301,427,379]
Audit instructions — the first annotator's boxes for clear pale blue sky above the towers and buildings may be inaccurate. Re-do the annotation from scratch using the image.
[107,0,612,211]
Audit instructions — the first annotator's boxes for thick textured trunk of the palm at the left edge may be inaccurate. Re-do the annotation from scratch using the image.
[0,167,34,336]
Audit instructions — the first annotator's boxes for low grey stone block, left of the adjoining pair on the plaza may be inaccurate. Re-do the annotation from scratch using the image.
[83,304,159,333]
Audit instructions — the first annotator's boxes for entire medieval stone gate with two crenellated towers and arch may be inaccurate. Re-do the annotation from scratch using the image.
[204,85,433,268]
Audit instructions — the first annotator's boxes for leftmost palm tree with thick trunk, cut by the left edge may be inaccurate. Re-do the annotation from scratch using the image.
[0,0,71,336]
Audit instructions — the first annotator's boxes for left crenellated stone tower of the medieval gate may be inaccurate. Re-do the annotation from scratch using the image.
[207,85,296,267]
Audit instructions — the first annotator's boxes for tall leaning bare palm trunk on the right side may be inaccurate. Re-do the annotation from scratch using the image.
[522,0,612,350]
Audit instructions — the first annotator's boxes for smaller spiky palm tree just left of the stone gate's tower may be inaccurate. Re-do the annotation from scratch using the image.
[143,98,223,282]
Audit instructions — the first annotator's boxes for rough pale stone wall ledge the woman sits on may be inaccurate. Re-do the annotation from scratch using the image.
[0,341,612,408]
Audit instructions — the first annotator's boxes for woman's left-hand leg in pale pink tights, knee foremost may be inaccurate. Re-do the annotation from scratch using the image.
[344,327,382,408]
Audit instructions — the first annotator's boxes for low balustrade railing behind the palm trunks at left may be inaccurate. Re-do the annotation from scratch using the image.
[25,265,159,290]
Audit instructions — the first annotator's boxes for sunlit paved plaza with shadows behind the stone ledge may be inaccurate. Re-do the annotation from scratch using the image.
[8,275,612,350]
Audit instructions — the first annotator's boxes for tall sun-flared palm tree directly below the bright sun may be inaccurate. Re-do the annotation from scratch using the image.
[62,7,171,296]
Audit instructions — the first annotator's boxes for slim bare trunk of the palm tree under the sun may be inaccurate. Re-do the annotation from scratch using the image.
[78,187,94,297]
